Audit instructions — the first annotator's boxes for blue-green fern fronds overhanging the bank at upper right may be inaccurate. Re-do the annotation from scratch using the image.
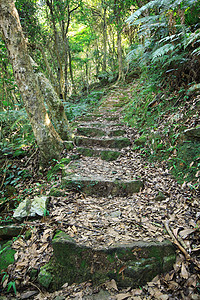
[127,0,200,89]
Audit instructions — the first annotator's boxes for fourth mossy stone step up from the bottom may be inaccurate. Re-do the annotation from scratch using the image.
[75,136,131,149]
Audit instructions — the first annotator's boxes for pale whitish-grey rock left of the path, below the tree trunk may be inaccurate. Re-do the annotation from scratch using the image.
[13,196,48,220]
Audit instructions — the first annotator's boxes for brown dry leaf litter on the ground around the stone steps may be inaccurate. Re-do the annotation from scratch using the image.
[0,81,200,300]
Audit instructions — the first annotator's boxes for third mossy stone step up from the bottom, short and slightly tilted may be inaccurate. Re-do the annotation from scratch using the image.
[77,147,121,161]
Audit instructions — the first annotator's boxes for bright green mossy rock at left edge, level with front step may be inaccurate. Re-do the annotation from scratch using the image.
[0,241,16,273]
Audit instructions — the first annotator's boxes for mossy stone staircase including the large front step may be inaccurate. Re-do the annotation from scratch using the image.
[44,103,176,290]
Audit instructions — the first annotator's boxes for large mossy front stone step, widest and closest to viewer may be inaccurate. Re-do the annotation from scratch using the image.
[39,231,176,290]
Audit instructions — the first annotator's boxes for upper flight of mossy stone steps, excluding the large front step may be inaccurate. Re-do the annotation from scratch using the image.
[62,111,143,197]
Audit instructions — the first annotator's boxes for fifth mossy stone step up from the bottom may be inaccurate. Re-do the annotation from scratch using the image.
[77,127,126,137]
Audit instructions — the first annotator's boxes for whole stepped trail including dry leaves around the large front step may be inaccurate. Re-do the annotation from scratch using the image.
[5,85,197,299]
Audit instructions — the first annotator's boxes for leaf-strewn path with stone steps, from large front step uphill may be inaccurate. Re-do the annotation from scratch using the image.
[45,86,195,287]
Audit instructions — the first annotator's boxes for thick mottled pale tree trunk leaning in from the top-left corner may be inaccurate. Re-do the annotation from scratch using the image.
[0,0,63,165]
